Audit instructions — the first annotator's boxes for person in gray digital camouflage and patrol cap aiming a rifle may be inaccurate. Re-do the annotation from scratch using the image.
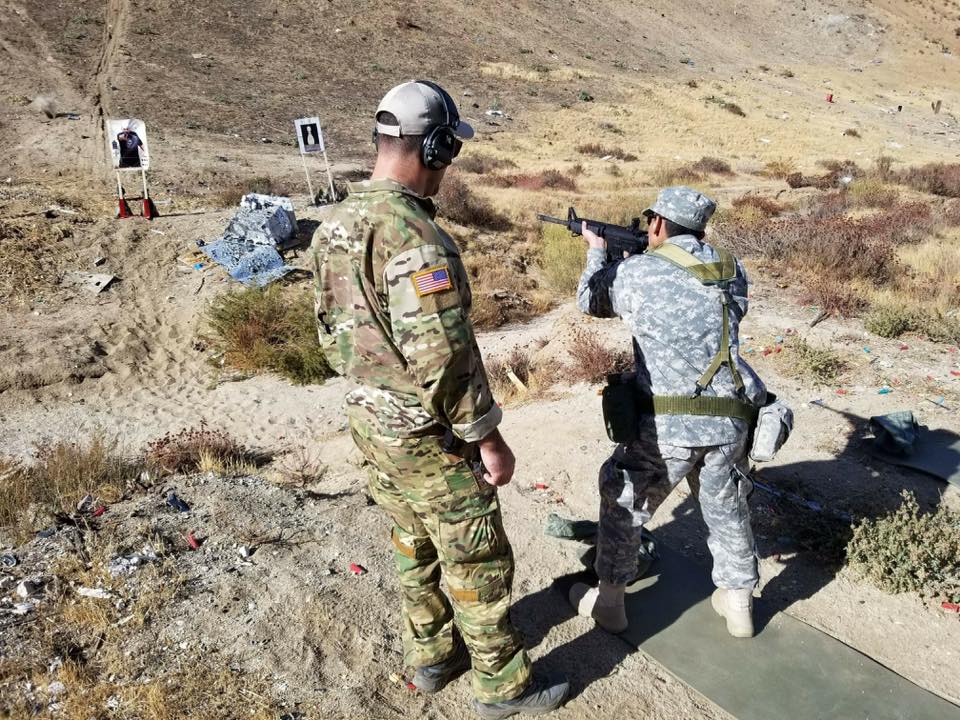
[570,187,766,637]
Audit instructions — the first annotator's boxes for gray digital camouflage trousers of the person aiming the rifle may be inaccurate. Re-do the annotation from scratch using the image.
[595,437,759,588]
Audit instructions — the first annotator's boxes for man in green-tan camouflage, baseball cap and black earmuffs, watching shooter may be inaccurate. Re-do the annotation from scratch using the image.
[310,81,568,718]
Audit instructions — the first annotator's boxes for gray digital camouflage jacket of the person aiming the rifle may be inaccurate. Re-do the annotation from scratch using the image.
[577,235,766,447]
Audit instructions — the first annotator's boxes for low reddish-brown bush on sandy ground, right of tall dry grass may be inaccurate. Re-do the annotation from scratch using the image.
[146,424,258,475]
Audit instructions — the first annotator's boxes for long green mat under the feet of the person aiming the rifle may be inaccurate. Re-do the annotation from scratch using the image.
[556,544,960,720]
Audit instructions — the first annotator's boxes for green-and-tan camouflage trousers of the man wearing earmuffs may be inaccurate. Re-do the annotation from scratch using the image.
[350,420,530,703]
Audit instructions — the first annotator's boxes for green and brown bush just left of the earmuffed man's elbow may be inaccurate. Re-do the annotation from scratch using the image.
[203,284,333,385]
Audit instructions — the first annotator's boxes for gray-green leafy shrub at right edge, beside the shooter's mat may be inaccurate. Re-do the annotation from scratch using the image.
[847,490,960,602]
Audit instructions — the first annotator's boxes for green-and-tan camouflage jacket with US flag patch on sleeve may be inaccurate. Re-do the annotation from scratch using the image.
[310,179,501,442]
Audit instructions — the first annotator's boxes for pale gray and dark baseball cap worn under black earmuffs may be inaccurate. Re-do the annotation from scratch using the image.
[377,80,473,140]
